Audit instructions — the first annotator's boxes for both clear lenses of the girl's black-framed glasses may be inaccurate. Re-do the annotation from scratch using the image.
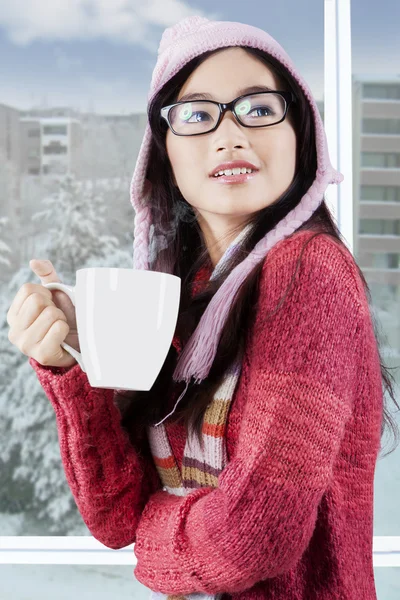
[169,93,286,135]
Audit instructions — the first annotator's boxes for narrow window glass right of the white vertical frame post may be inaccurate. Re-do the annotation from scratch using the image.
[352,0,400,556]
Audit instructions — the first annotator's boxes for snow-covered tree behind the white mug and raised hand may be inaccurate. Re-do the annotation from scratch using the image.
[0,171,133,535]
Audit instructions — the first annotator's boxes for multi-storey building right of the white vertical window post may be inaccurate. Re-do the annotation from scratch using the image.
[353,74,400,348]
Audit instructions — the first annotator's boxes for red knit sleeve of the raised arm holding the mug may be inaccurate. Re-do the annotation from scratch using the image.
[29,358,162,549]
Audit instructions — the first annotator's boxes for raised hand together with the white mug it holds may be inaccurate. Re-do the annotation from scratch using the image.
[9,261,181,391]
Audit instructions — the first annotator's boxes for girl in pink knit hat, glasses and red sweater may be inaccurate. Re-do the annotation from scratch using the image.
[17,12,396,600]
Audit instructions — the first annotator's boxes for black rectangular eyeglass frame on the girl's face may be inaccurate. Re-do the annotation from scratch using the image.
[160,90,296,137]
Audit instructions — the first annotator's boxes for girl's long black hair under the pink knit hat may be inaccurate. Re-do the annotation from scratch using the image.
[117,47,399,454]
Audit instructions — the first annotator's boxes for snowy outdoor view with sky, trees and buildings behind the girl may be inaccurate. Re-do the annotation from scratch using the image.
[0,0,400,600]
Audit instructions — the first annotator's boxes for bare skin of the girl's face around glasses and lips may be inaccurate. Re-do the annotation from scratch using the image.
[166,47,296,266]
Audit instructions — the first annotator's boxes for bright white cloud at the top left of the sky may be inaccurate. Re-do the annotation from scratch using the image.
[0,0,216,52]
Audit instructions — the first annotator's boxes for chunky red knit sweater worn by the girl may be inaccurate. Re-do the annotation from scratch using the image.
[29,231,383,600]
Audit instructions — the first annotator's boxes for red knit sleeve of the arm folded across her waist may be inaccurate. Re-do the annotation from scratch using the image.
[134,234,363,594]
